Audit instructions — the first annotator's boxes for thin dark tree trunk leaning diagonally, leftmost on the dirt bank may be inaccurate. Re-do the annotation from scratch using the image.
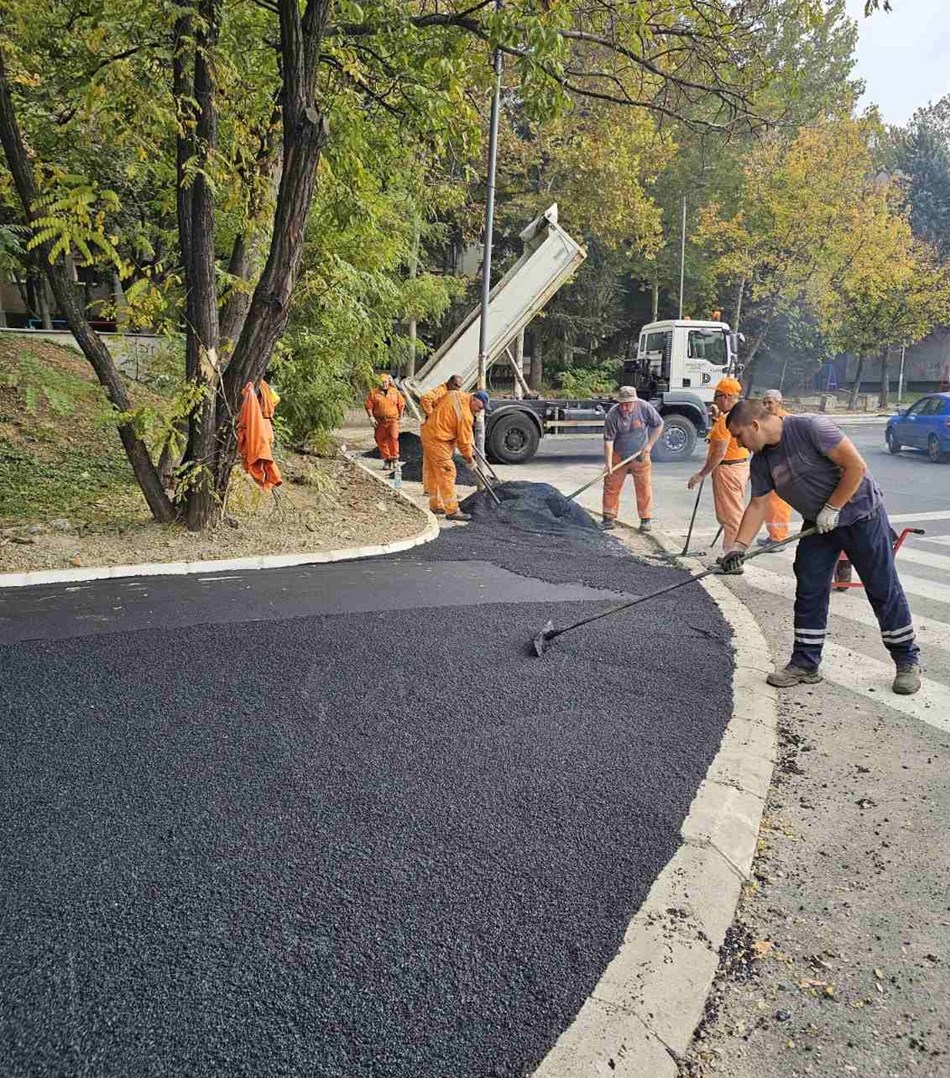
[0,50,175,523]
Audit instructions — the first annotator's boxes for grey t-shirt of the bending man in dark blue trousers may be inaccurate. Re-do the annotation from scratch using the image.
[751,415,883,525]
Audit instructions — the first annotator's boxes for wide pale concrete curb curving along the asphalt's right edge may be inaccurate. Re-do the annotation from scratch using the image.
[534,525,776,1078]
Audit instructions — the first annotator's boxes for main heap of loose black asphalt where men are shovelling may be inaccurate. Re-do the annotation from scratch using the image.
[462,480,624,553]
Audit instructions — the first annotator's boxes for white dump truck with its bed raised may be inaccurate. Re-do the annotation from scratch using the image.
[400,205,736,464]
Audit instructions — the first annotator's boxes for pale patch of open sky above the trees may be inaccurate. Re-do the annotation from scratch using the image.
[846,0,950,124]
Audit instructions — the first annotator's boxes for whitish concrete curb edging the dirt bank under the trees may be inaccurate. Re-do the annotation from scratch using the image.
[0,456,439,589]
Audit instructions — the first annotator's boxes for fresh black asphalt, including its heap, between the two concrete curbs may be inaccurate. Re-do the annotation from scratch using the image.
[0,493,731,1078]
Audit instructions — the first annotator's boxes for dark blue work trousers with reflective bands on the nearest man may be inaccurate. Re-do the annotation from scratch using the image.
[791,509,920,669]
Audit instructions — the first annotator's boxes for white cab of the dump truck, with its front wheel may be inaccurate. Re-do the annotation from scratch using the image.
[621,318,739,460]
